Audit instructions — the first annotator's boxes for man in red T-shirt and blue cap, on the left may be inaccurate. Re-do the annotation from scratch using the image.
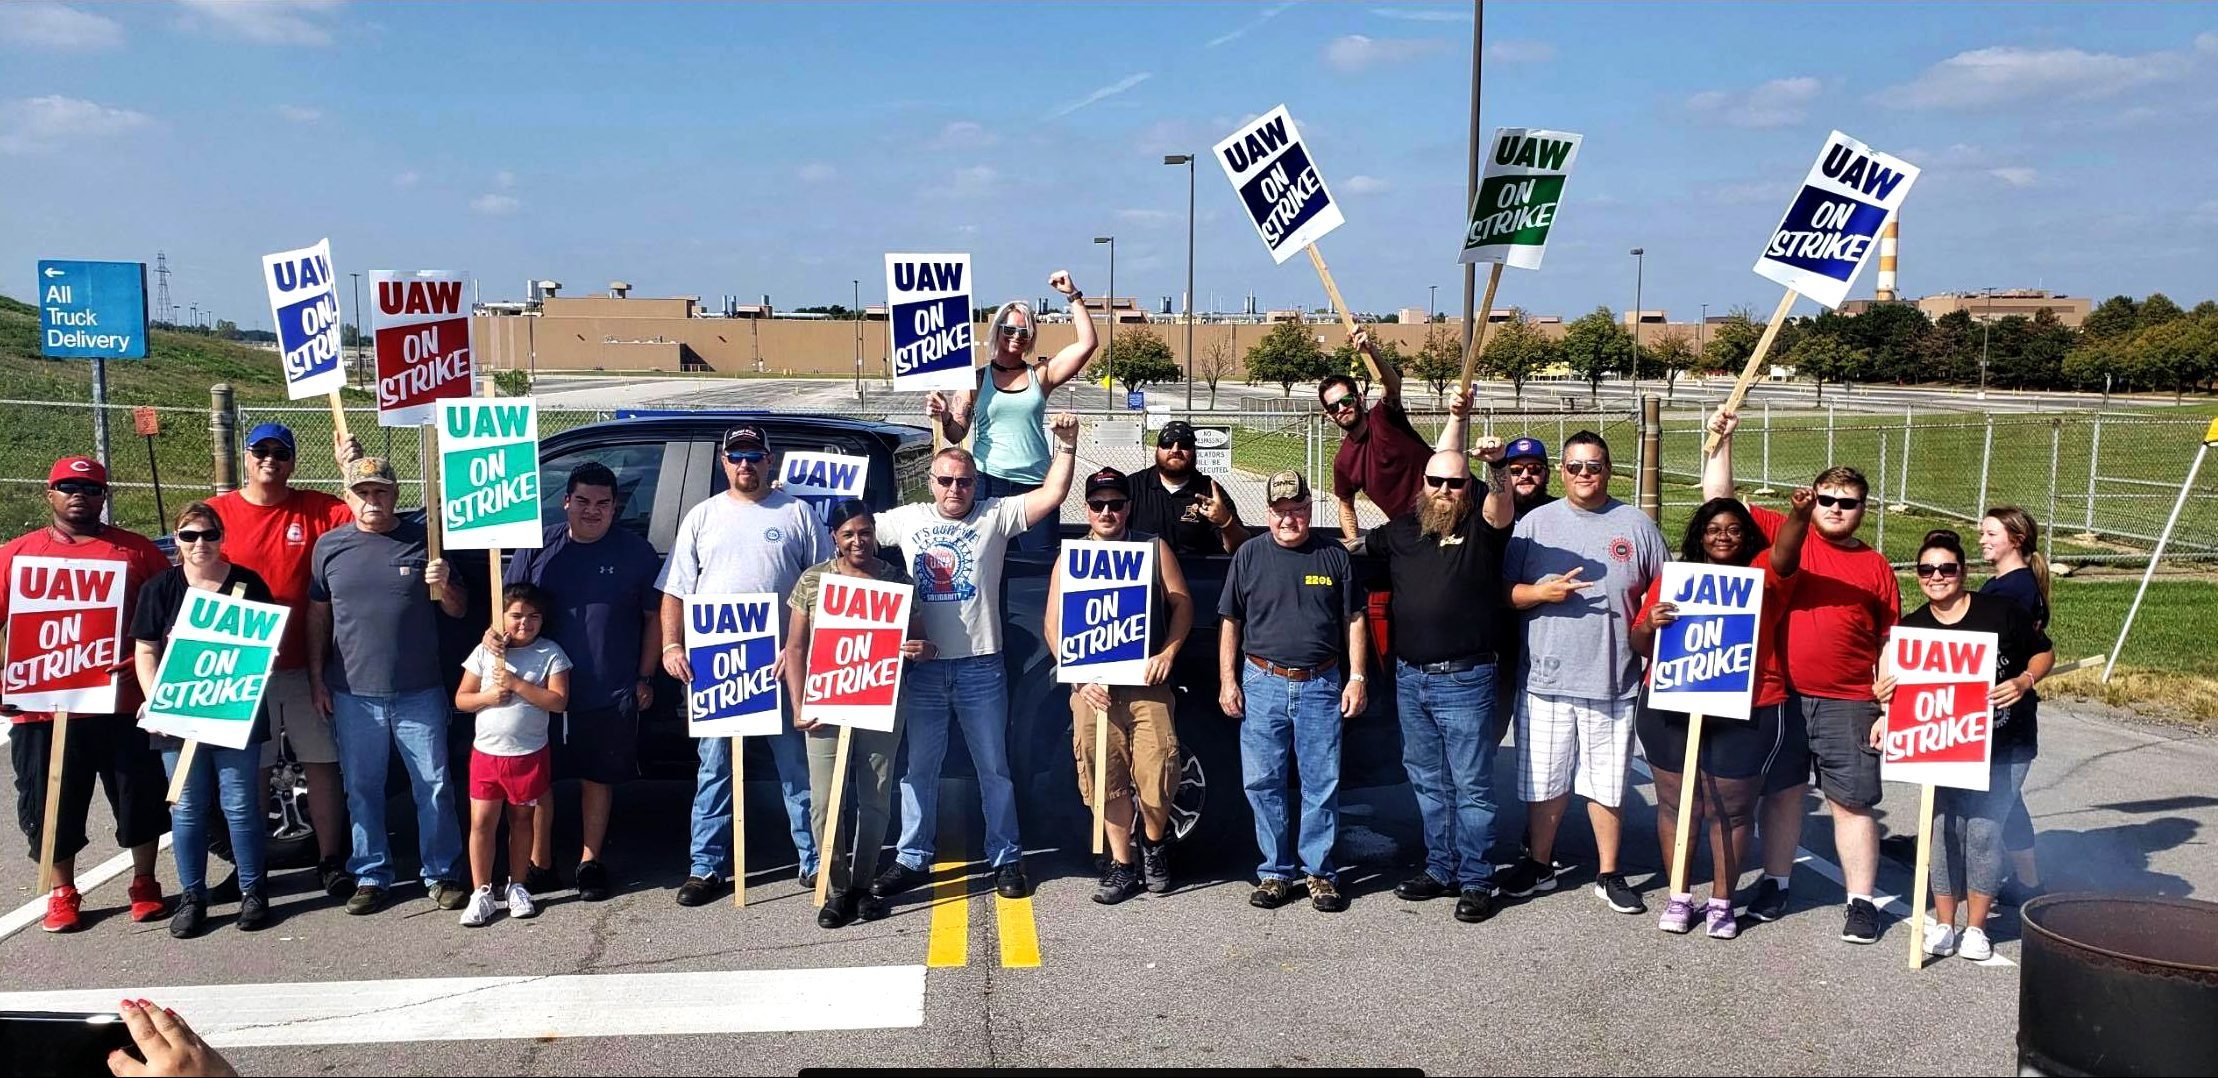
[208,424,359,898]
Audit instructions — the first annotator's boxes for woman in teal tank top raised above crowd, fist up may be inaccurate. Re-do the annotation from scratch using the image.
[925,271,1095,550]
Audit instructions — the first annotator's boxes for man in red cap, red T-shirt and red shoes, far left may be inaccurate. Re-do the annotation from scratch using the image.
[0,457,169,932]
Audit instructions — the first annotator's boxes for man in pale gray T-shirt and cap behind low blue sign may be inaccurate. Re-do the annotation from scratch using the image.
[654,424,832,905]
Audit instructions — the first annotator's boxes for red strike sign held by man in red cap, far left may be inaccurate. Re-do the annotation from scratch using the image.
[0,557,126,714]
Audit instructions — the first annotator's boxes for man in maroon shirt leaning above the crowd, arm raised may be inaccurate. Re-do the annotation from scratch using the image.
[1317,330,1464,548]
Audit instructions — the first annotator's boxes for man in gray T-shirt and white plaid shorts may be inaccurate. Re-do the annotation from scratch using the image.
[1499,430,1664,914]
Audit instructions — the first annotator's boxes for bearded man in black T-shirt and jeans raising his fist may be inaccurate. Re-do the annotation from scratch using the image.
[1369,439,1510,923]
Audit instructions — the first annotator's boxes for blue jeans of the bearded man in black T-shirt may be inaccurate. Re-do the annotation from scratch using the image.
[1395,661,1495,889]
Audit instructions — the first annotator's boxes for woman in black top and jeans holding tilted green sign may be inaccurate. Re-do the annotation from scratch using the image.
[131,501,277,940]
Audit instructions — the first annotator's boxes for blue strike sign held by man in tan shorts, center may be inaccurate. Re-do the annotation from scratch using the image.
[1056,541,1156,685]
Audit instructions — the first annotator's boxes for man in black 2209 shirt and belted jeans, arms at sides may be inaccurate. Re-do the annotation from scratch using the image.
[1218,470,1371,914]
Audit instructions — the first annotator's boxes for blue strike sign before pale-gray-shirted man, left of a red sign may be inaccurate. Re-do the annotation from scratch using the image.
[685,592,785,736]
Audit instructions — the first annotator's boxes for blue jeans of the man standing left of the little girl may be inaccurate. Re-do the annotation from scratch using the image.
[330,688,461,887]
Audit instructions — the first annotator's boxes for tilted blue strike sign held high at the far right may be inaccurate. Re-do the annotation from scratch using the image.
[1757,131,1919,308]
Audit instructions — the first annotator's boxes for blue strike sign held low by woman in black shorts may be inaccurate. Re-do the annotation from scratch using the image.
[1648,561,1763,719]
